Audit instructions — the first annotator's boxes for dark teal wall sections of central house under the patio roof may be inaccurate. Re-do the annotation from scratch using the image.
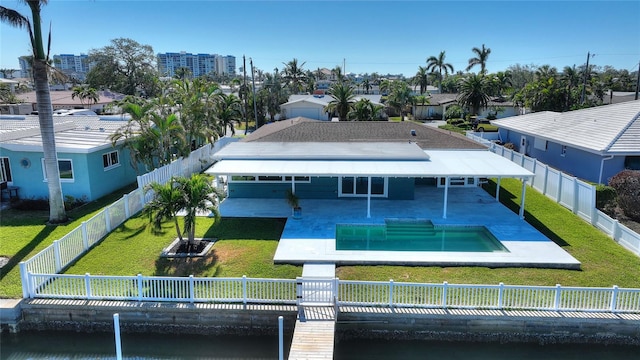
[228,177,415,200]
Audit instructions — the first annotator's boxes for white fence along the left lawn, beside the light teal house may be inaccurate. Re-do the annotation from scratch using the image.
[20,138,233,297]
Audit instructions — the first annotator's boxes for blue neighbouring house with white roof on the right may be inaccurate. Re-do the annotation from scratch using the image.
[491,100,640,183]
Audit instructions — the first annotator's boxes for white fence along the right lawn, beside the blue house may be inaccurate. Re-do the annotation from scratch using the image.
[467,133,640,255]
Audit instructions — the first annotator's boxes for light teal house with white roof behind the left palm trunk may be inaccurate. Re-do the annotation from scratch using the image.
[0,116,136,201]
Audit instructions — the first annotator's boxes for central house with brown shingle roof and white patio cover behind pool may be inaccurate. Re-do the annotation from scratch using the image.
[206,118,533,217]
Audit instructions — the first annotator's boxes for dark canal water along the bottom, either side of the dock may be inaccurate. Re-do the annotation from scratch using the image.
[0,331,640,360]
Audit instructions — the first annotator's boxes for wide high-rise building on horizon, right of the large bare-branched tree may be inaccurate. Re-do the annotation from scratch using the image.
[158,51,236,77]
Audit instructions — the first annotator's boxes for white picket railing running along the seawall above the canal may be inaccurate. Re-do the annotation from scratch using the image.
[20,272,640,313]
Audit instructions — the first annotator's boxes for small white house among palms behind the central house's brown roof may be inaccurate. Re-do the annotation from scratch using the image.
[280,94,382,121]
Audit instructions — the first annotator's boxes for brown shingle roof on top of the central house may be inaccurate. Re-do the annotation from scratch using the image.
[242,118,486,149]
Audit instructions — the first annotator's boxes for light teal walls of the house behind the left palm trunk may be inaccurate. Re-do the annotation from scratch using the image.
[0,147,136,201]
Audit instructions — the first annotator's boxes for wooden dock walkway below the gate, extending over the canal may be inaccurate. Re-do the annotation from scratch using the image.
[288,306,336,360]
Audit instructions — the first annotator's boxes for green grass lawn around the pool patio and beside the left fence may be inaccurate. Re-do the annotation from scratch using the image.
[0,179,640,297]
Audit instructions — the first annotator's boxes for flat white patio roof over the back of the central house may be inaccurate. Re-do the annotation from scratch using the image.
[206,150,534,178]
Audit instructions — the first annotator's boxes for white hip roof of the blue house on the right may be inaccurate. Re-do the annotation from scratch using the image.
[492,100,640,154]
